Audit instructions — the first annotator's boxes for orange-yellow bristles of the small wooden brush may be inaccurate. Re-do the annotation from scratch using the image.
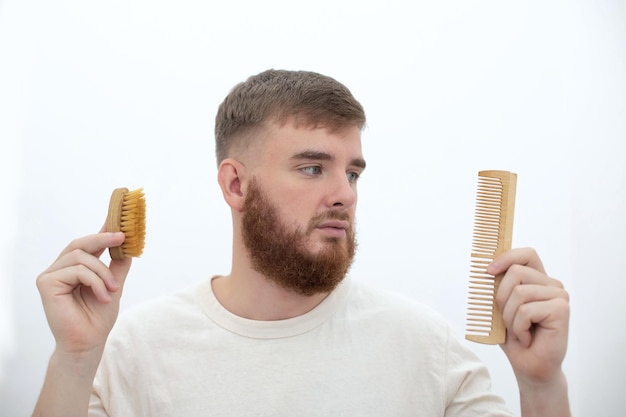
[120,188,146,257]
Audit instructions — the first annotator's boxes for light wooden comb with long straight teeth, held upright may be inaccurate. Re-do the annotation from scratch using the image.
[465,171,517,345]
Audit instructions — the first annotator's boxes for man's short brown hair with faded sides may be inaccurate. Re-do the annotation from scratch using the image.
[215,69,365,165]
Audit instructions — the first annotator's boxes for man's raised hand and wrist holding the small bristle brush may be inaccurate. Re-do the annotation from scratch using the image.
[33,231,131,417]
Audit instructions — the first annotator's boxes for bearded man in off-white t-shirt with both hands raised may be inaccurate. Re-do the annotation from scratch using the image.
[34,70,570,417]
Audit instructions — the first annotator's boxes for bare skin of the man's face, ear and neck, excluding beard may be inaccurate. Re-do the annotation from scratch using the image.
[213,120,365,320]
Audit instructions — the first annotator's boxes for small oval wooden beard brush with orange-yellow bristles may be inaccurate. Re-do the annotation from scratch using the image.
[106,188,146,259]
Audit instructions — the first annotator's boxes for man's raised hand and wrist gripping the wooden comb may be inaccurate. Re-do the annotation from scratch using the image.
[488,248,571,417]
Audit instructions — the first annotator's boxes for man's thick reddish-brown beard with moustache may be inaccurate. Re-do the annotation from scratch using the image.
[242,179,357,296]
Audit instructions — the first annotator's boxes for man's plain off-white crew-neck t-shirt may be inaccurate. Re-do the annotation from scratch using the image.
[89,279,512,417]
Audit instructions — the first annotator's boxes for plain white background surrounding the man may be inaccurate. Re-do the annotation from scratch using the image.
[0,0,626,417]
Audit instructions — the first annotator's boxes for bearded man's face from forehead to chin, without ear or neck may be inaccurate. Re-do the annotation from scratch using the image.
[242,122,365,295]
